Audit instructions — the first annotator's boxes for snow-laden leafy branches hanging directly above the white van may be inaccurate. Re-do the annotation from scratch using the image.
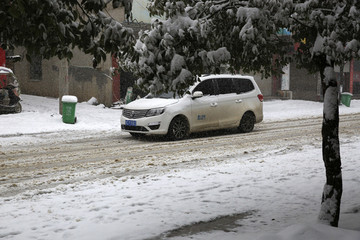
[122,1,291,94]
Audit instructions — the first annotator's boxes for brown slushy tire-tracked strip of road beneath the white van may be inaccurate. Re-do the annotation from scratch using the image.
[0,114,360,196]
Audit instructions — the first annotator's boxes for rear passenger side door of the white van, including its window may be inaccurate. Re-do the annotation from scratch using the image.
[216,78,242,128]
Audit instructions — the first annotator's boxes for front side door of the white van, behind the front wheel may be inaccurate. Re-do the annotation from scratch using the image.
[190,79,219,132]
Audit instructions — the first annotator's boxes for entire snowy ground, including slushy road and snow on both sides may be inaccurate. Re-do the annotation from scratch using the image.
[0,96,360,240]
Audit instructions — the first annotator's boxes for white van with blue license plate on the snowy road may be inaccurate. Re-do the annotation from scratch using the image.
[120,74,263,140]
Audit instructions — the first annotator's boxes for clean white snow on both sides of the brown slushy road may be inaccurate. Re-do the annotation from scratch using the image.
[0,95,360,240]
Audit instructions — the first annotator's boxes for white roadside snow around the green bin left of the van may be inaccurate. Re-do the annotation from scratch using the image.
[0,94,121,135]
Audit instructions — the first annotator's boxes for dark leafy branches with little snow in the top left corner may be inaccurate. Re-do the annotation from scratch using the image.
[0,0,134,61]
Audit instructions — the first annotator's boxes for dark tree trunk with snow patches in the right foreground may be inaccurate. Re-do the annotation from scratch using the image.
[319,64,342,227]
